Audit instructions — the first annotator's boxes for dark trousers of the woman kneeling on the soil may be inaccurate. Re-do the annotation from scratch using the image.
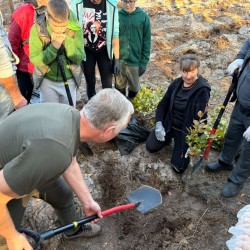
[146,128,190,172]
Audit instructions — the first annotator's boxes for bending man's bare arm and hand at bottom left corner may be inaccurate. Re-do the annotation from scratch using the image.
[0,170,32,250]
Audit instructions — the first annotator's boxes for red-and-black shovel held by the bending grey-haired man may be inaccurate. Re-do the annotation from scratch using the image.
[18,185,162,249]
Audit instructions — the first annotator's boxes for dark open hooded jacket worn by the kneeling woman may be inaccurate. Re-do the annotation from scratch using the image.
[155,76,211,147]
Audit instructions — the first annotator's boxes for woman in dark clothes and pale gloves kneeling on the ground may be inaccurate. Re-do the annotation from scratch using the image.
[146,54,211,173]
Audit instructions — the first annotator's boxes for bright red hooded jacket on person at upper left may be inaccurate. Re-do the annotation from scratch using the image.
[8,3,35,73]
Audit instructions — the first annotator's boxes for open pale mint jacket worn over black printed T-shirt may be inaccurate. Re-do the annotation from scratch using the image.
[70,0,119,60]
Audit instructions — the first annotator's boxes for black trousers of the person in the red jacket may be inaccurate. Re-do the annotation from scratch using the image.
[16,70,33,103]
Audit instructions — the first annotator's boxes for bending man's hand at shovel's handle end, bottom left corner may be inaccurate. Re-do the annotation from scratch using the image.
[6,232,33,250]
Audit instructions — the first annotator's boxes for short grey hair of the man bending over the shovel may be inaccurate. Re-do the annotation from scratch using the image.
[82,88,134,129]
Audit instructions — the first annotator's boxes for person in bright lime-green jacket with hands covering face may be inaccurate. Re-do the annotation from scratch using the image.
[30,0,85,106]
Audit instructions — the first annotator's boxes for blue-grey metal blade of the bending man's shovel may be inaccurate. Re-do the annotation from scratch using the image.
[128,185,162,214]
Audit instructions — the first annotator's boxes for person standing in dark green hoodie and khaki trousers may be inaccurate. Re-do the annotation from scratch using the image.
[116,0,151,99]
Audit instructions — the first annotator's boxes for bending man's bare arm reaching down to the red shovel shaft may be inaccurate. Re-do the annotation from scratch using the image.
[63,157,102,218]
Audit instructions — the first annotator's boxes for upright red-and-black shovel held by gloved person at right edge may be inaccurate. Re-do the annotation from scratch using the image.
[191,71,238,175]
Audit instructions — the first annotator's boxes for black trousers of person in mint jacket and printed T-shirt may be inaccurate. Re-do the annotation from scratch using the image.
[82,49,113,99]
